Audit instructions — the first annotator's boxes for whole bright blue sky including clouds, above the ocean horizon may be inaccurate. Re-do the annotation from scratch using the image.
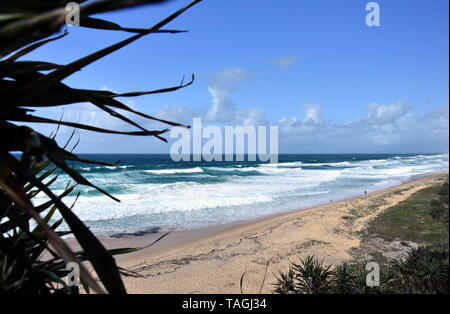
[23,0,449,153]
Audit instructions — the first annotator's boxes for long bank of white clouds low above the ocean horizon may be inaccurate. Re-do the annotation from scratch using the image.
[26,71,449,153]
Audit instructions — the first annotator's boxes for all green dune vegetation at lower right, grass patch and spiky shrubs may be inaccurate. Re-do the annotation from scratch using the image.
[274,178,449,294]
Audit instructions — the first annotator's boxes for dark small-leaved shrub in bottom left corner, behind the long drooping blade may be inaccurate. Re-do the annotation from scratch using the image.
[0,162,76,294]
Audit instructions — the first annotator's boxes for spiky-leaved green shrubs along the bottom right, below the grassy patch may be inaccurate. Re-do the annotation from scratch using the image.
[274,242,449,294]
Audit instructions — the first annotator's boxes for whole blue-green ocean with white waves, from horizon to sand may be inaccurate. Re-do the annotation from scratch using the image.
[34,154,449,236]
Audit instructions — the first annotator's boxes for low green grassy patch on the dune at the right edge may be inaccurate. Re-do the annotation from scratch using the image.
[366,180,448,244]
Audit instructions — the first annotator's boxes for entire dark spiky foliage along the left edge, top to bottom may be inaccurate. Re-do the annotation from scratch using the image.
[0,0,201,293]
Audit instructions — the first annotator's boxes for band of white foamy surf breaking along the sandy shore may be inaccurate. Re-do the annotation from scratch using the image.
[36,154,448,232]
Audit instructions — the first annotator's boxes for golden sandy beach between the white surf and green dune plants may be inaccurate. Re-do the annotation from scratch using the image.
[108,171,448,294]
